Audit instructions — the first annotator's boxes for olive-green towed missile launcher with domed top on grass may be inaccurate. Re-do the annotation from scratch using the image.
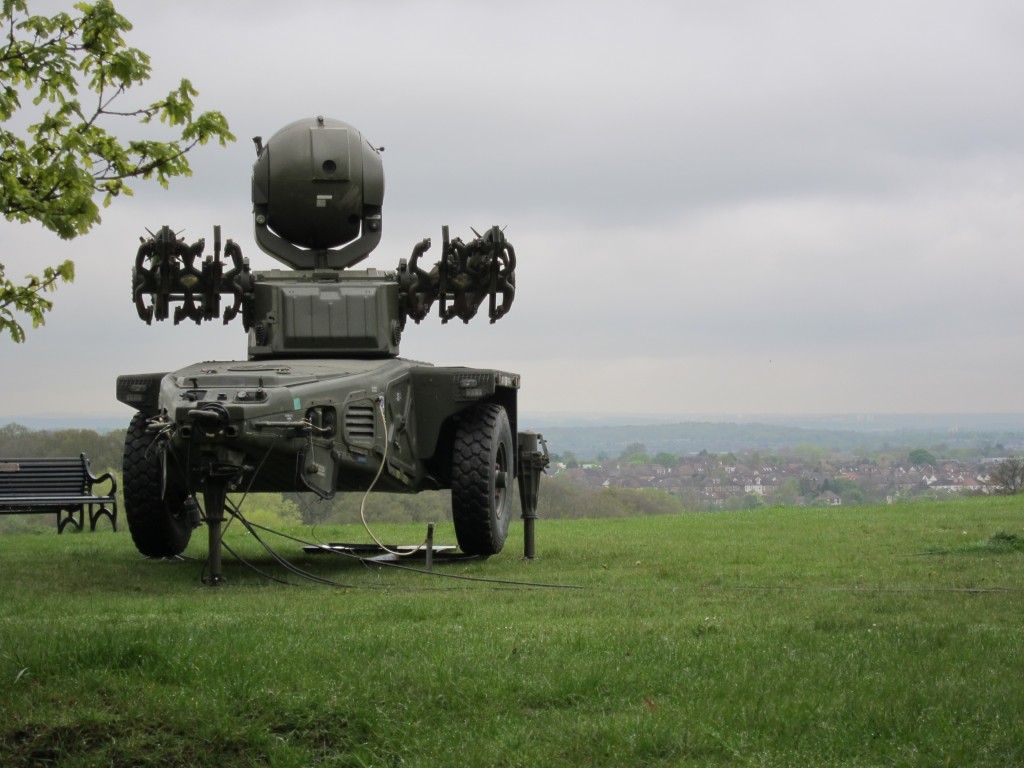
[117,117,547,582]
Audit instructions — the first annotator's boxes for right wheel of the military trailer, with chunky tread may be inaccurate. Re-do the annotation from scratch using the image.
[452,404,515,556]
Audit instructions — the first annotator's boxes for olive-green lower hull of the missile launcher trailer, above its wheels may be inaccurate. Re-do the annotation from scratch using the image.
[118,357,519,498]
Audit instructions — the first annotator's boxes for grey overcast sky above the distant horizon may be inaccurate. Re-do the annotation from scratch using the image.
[0,0,1024,426]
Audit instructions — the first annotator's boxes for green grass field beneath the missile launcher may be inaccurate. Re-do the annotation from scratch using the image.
[0,498,1024,767]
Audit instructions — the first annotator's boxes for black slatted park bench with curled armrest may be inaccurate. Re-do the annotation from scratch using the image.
[0,454,118,534]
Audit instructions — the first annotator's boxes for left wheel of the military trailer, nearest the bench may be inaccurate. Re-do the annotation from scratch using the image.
[122,413,191,557]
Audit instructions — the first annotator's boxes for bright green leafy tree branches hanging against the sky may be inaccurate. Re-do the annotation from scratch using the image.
[0,0,234,342]
